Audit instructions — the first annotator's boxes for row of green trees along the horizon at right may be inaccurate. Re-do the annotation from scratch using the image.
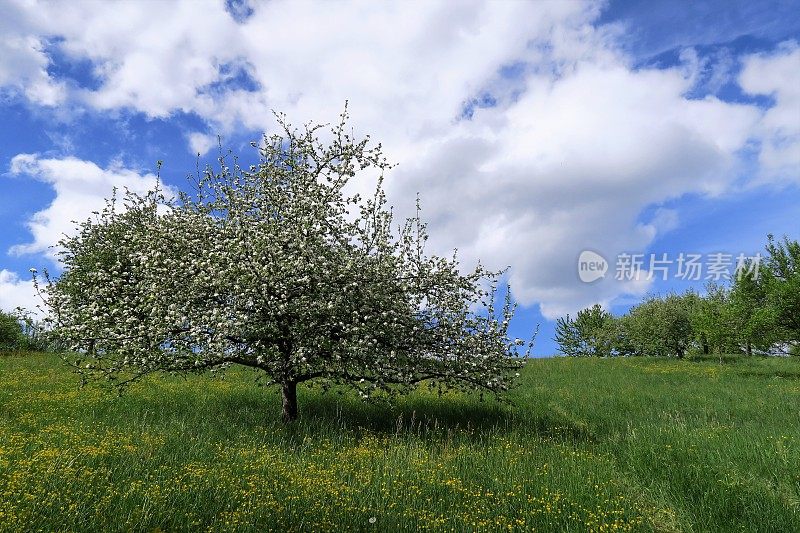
[555,235,800,358]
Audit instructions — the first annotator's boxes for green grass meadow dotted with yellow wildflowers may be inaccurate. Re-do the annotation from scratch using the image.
[0,355,800,531]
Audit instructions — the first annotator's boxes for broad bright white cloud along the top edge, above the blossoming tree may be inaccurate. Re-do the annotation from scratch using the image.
[1,0,597,137]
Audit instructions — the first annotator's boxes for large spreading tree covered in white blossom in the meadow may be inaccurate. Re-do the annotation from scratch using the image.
[43,110,527,421]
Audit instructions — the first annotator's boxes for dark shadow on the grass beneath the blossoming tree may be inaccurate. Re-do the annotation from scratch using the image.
[117,376,596,446]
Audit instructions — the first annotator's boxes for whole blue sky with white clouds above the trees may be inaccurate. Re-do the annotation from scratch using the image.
[0,0,800,355]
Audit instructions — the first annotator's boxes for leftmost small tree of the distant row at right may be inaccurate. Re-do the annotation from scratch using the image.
[554,304,616,357]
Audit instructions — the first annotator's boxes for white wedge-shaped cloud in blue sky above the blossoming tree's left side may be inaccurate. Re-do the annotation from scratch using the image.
[10,154,167,258]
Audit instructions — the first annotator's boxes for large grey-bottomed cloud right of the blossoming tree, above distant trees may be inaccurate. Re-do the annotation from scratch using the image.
[395,60,759,317]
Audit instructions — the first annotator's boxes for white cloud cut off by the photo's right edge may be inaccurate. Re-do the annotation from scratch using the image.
[739,41,800,182]
